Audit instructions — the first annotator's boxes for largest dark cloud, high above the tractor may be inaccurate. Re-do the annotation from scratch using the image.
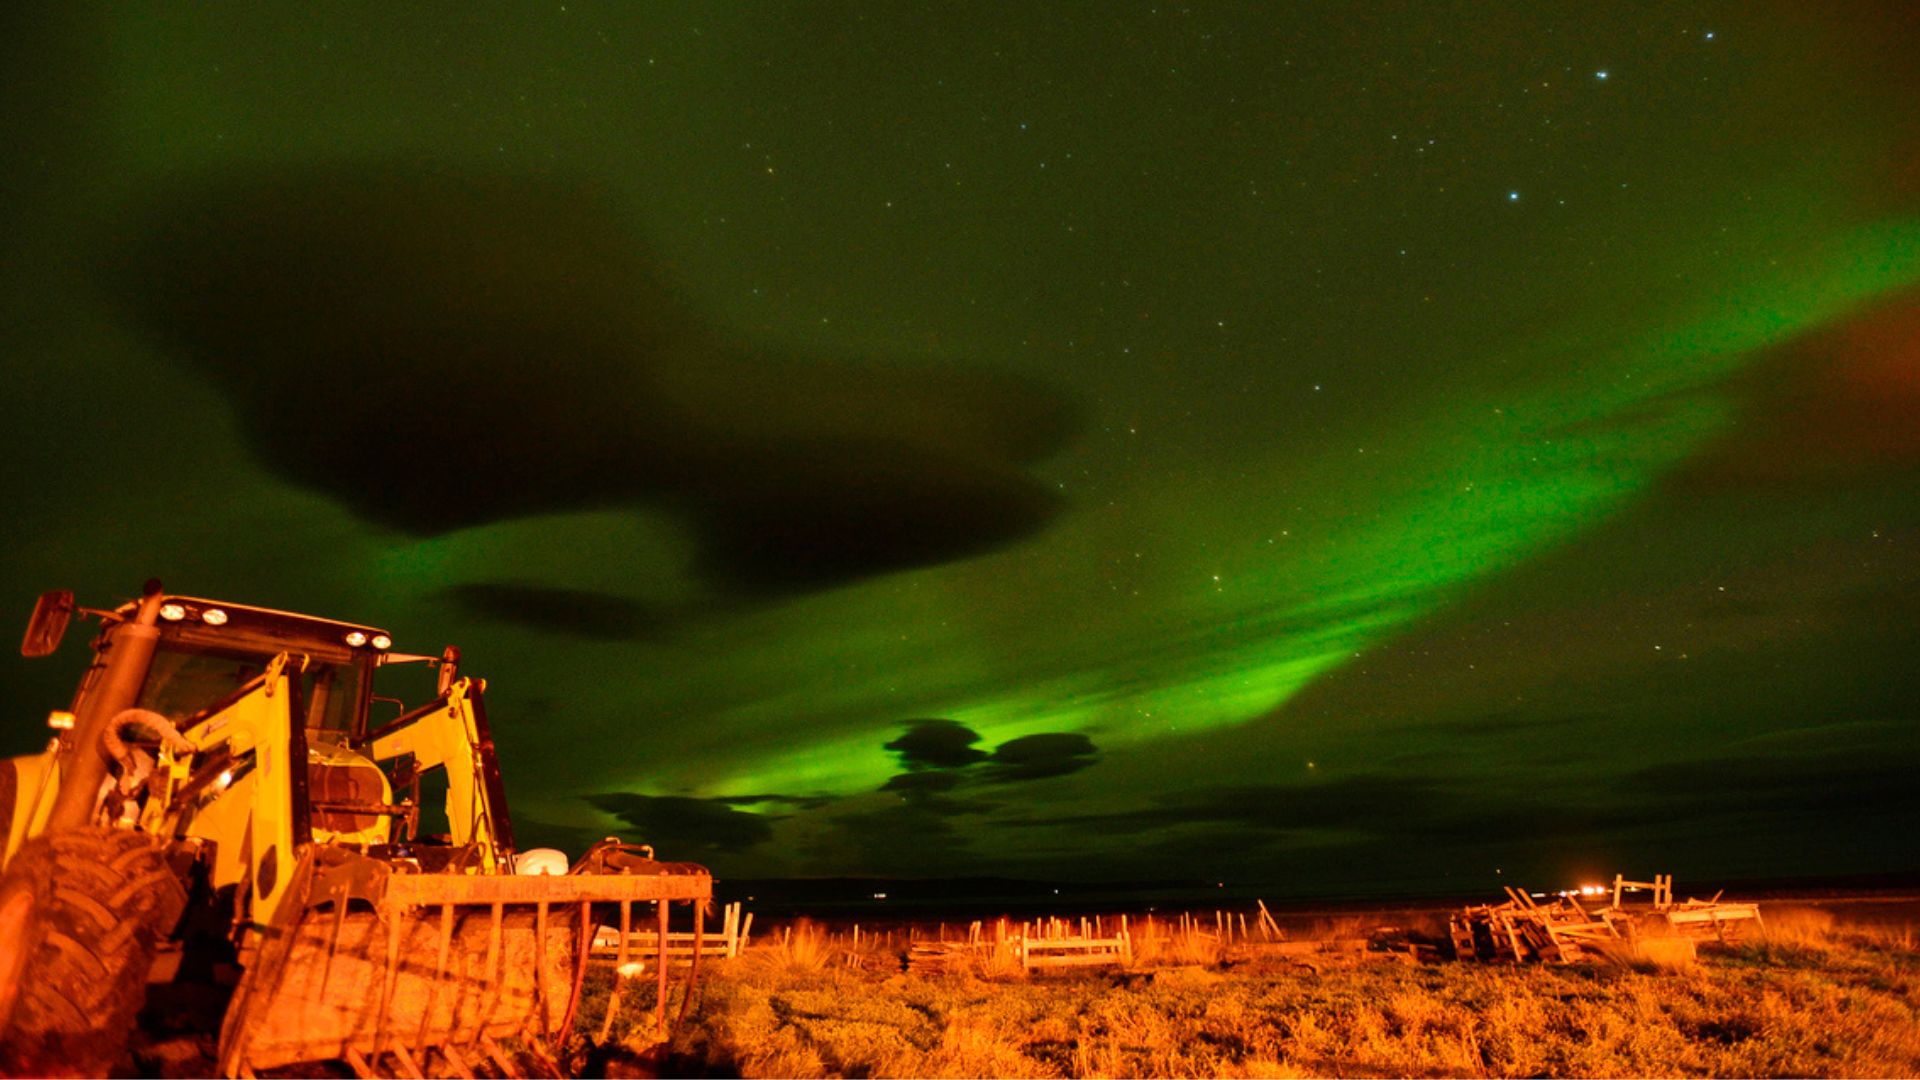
[108,163,1073,595]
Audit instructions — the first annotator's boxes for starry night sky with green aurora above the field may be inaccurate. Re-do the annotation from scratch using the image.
[0,0,1920,894]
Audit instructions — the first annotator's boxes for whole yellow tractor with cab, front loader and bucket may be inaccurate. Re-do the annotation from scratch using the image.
[0,582,712,1076]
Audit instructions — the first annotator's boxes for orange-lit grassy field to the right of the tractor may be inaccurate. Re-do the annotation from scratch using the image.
[580,909,1920,1076]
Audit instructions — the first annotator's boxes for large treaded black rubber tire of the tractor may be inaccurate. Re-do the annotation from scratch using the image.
[0,828,186,1076]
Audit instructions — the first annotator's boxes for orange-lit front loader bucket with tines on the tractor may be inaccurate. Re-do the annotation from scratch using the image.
[219,847,712,1076]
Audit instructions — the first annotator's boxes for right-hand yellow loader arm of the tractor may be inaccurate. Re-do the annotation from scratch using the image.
[369,678,513,874]
